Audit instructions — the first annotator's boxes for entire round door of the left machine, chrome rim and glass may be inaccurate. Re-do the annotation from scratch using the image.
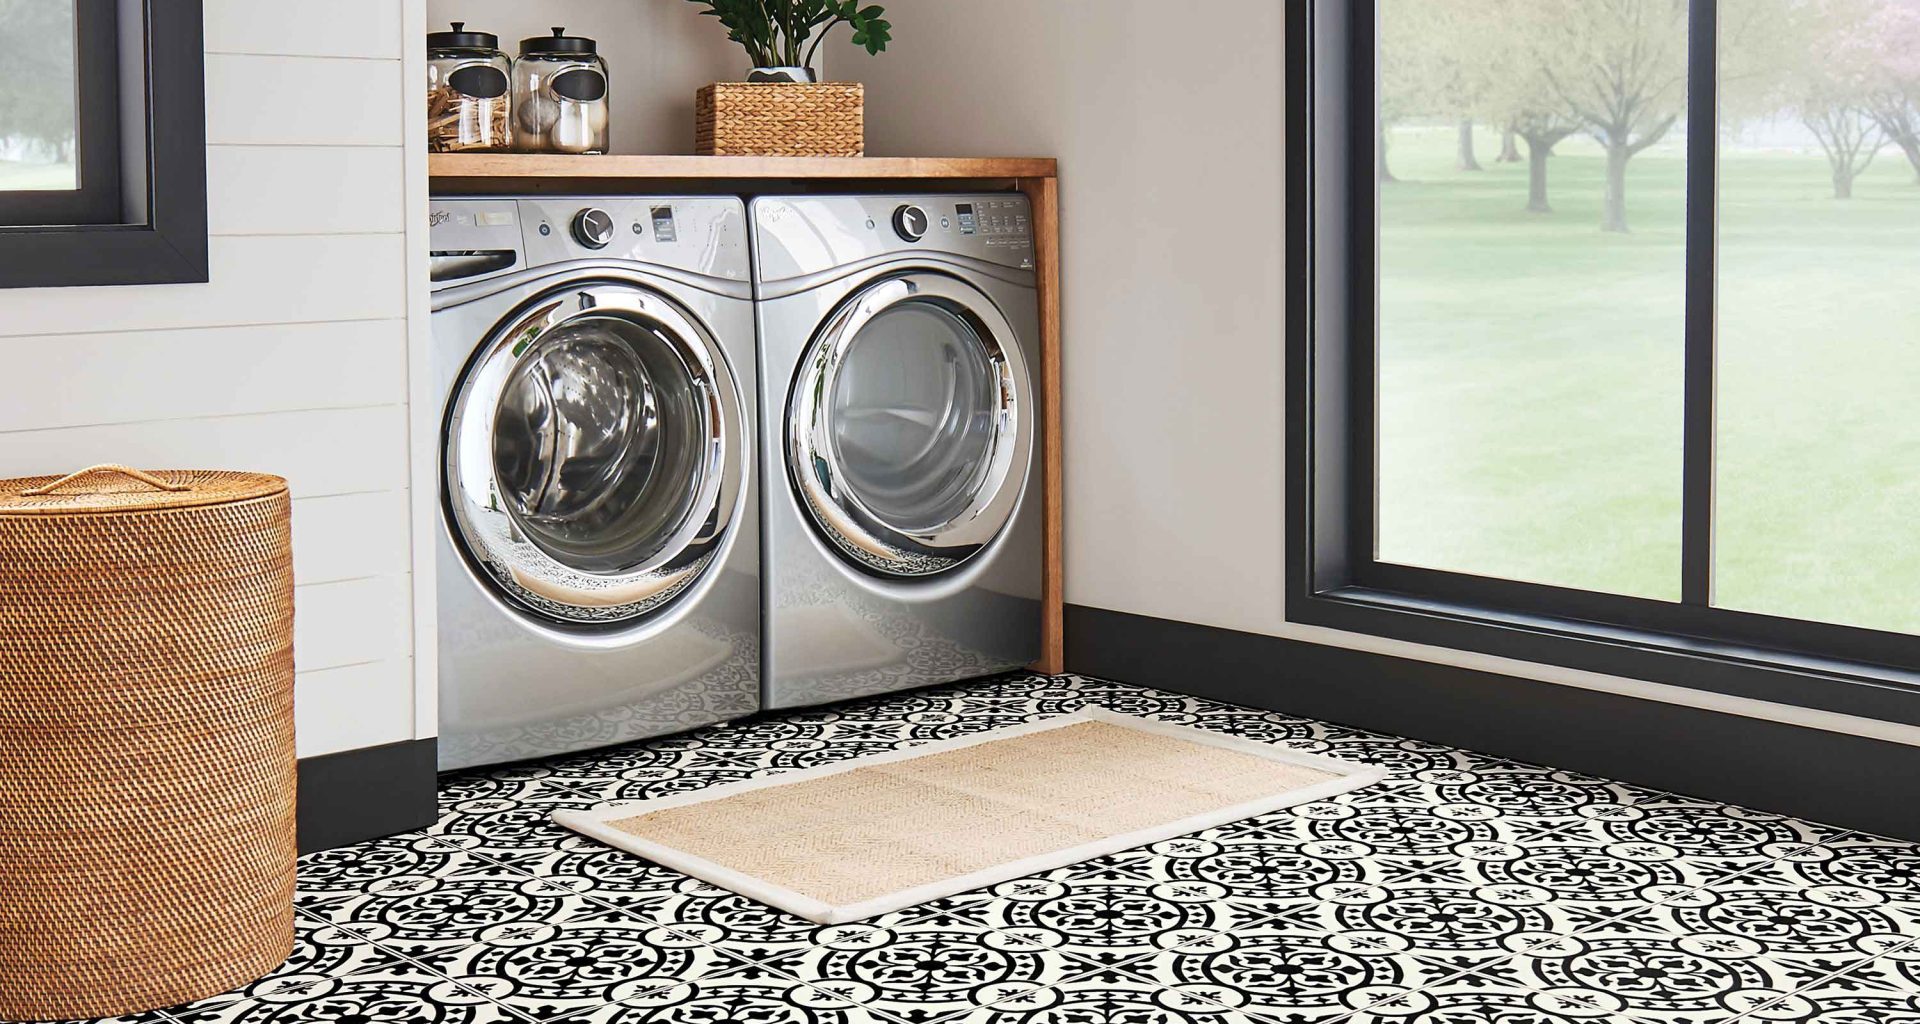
[445,280,747,624]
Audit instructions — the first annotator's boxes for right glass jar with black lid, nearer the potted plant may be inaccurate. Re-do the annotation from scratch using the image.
[513,27,607,154]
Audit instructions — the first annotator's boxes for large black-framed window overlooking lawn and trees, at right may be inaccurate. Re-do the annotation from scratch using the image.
[1288,0,1920,722]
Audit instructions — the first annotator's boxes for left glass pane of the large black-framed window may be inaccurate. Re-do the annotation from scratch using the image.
[1377,0,1688,599]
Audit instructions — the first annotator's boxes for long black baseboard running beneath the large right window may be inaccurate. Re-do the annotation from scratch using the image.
[1066,605,1920,840]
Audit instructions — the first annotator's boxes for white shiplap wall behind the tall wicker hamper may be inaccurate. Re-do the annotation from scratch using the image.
[0,0,434,757]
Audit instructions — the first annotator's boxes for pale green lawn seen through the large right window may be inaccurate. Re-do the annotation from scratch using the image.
[1379,119,1920,632]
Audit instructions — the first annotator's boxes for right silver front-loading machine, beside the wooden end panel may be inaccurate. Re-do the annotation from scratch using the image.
[749,194,1043,707]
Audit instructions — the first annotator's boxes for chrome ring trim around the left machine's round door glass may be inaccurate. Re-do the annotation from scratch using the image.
[442,279,751,624]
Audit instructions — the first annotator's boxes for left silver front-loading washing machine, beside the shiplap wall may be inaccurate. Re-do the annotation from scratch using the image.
[430,196,760,770]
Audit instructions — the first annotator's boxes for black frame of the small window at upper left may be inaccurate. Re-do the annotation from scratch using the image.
[0,0,207,288]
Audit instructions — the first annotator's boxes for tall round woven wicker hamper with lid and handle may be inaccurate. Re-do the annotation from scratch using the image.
[0,467,296,1018]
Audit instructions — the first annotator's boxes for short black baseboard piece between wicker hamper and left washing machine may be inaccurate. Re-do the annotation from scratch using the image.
[296,740,440,853]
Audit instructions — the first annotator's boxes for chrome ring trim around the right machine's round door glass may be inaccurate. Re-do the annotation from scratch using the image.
[787,269,1037,576]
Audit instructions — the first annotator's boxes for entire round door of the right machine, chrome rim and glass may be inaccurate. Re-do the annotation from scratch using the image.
[787,271,1035,576]
